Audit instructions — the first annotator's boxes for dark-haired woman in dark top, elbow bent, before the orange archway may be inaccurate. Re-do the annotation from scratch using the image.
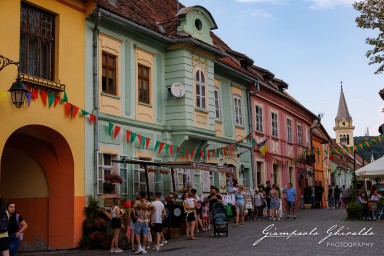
[7,202,28,256]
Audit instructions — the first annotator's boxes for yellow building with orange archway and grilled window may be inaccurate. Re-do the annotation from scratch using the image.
[0,0,92,249]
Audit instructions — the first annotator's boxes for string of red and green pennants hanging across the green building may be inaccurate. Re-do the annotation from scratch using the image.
[108,122,264,160]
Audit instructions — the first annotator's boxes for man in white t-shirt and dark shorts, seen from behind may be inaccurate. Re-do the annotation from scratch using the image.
[151,192,166,251]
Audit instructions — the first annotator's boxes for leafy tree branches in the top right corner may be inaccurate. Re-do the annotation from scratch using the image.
[353,0,384,74]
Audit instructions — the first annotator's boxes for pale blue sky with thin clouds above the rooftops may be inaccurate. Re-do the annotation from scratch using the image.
[180,0,384,138]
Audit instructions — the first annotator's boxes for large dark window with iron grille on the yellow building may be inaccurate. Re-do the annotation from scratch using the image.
[19,3,55,80]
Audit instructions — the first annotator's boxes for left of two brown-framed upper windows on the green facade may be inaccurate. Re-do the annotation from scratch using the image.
[101,52,116,95]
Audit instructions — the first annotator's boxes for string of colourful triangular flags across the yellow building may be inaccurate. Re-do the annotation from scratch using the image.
[0,88,96,123]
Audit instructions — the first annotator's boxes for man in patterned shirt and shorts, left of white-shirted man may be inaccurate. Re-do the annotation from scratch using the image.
[133,192,153,254]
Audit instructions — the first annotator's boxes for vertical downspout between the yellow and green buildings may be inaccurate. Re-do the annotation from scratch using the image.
[92,7,101,197]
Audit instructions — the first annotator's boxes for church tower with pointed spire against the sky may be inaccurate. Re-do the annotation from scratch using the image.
[333,82,355,147]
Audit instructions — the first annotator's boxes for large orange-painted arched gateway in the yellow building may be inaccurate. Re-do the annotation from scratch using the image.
[0,125,74,249]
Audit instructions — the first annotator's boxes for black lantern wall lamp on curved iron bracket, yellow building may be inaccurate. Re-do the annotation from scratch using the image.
[0,55,28,108]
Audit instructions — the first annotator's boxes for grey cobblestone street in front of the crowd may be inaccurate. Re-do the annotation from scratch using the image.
[20,209,384,256]
